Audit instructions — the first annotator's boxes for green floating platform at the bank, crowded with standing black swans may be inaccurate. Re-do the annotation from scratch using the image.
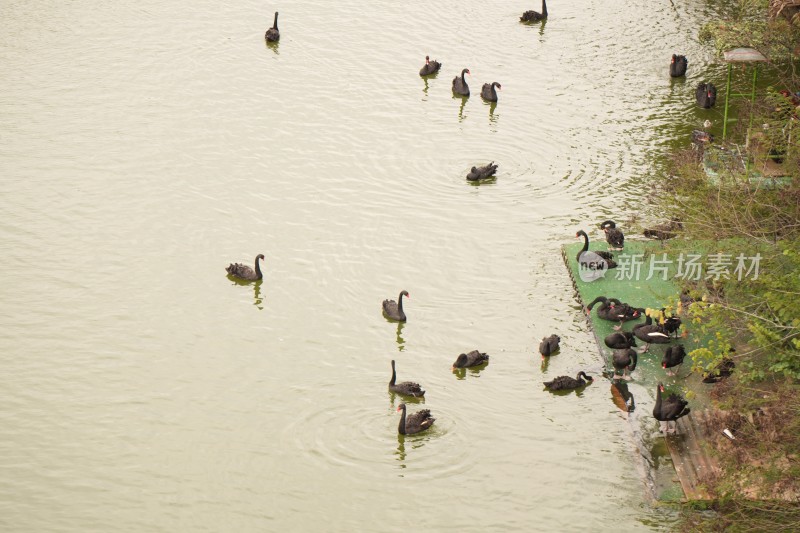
[562,239,717,501]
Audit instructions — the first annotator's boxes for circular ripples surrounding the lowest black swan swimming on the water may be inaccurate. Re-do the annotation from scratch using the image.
[280,388,478,478]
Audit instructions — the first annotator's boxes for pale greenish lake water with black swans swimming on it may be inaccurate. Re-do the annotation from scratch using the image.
[0,0,719,532]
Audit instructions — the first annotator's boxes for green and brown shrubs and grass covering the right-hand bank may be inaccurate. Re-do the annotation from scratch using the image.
[657,0,800,531]
